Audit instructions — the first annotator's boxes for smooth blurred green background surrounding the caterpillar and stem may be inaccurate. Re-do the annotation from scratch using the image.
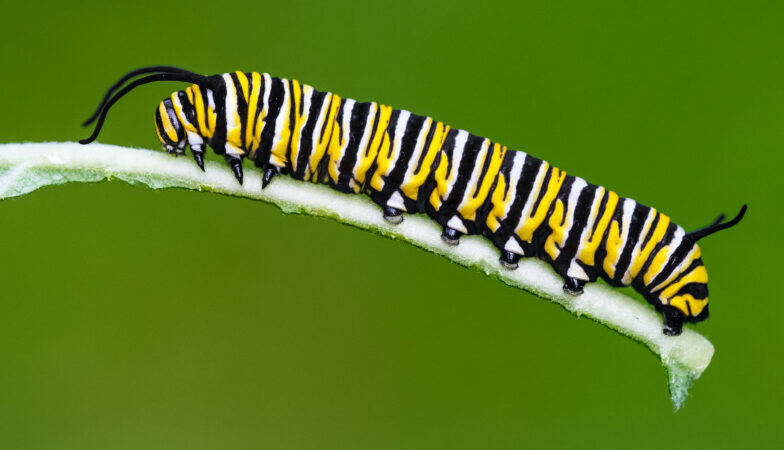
[0,1,784,449]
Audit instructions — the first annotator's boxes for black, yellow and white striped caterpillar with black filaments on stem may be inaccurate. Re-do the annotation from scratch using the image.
[79,66,746,335]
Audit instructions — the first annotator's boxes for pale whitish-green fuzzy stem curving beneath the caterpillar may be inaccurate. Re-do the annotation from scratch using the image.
[0,143,713,409]
